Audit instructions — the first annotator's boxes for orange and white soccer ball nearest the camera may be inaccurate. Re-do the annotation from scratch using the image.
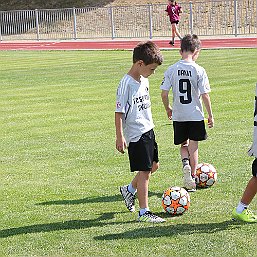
[162,186,190,215]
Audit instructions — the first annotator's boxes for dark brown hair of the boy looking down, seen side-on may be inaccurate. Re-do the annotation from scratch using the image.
[133,41,163,65]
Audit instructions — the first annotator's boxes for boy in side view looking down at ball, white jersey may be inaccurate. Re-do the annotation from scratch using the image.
[115,41,165,223]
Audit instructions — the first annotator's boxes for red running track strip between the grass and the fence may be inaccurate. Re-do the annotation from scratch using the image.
[0,37,257,50]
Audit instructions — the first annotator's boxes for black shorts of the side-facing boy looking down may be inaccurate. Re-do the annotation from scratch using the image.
[128,129,159,172]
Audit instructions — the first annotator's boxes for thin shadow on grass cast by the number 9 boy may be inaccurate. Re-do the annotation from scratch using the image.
[36,192,162,205]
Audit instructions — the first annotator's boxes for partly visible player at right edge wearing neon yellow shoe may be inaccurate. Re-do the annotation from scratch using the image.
[232,84,257,223]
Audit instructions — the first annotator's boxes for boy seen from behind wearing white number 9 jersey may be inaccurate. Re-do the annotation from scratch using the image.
[160,35,214,191]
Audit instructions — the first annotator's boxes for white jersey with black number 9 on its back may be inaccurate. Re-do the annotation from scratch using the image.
[160,60,211,121]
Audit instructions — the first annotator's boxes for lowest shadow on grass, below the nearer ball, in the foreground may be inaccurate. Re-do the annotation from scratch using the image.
[94,220,244,240]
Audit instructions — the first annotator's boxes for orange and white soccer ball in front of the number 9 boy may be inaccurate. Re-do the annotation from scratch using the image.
[196,163,217,188]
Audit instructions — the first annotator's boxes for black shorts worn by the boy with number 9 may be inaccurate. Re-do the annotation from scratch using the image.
[173,120,207,145]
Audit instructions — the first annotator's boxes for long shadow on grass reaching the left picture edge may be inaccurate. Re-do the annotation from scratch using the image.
[0,212,132,238]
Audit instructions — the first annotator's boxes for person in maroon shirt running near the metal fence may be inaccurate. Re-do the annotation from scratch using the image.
[165,0,182,46]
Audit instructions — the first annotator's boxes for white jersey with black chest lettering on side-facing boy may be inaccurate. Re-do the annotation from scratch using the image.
[115,74,154,144]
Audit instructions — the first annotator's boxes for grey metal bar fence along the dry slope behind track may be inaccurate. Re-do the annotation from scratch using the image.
[0,0,257,41]
